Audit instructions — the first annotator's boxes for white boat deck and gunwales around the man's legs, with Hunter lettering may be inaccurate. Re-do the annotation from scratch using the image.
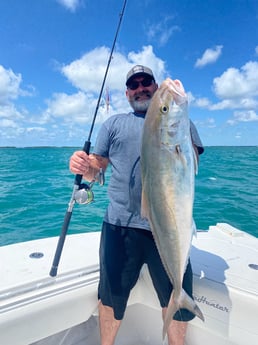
[0,224,258,345]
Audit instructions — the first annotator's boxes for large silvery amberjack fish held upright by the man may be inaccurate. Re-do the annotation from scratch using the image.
[141,79,204,337]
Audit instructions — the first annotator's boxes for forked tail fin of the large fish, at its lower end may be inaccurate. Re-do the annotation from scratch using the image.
[163,290,204,339]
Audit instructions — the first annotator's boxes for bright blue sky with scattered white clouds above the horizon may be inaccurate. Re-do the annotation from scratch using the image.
[0,0,258,147]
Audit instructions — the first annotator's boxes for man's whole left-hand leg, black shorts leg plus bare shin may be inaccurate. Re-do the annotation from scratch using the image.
[98,222,144,345]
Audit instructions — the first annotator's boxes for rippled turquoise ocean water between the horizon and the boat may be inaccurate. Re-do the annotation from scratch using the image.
[0,147,258,246]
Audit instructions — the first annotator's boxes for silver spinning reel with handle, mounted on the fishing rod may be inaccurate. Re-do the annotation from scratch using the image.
[74,169,105,205]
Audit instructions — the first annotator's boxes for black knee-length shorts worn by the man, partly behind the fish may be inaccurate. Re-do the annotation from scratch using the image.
[98,222,195,321]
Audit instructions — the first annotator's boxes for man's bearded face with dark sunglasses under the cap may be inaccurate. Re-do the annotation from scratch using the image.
[126,76,158,113]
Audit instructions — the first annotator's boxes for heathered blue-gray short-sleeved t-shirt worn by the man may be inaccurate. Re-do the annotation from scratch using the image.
[93,112,203,230]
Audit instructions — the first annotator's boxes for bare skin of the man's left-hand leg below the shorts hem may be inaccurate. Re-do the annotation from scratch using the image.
[99,301,121,345]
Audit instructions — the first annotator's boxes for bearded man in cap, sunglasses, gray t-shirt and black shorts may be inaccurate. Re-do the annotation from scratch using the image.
[70,65,203,345]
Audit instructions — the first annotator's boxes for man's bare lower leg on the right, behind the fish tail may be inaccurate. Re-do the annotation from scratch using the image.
[162,308,187,345]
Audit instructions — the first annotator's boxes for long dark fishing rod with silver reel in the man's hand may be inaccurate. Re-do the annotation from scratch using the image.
[49,0,127,277]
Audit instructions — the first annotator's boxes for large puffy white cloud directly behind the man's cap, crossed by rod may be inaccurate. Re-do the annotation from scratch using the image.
[61,46,165,93]
